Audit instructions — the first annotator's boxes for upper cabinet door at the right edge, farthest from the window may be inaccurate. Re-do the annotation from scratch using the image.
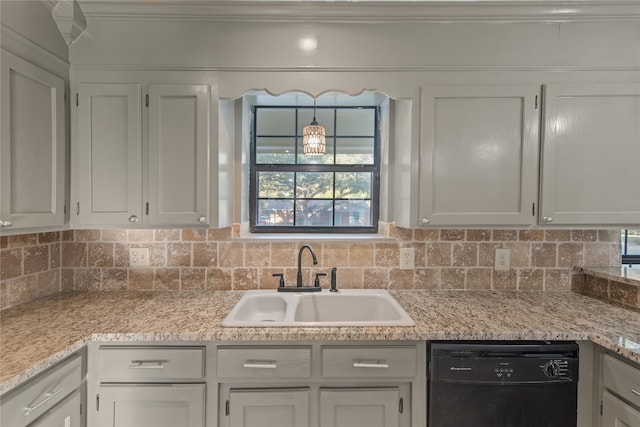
[541,83,640,225]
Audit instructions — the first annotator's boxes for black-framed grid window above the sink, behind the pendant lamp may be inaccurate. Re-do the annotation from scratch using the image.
[249,105,380,233]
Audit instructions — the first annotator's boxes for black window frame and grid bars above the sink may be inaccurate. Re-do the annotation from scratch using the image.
[249,104,381,234]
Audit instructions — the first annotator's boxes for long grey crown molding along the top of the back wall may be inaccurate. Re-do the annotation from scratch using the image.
[74,0,640,22]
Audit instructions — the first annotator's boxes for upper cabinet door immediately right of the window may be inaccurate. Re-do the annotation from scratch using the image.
[419,85,539,226]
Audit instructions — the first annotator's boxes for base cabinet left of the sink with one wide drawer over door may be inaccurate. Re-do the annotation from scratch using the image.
[88,345,207,427]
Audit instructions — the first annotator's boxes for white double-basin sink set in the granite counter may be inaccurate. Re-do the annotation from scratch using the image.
[222,289,415,328]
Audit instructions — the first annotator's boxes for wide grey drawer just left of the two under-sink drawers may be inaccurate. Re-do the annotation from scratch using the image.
[99,346,205,382]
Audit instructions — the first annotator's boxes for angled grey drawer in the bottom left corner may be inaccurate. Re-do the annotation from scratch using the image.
[0,355,82,427]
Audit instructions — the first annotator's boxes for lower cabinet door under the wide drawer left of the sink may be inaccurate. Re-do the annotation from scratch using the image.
[97,384,205,427]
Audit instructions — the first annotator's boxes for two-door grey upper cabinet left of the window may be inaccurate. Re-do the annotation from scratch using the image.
[72,83,210,228]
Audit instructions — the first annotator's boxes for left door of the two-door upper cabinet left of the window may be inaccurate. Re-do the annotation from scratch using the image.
[72,84,142,227]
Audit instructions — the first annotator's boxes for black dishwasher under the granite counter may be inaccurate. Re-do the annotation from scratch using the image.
[428,341,578,427]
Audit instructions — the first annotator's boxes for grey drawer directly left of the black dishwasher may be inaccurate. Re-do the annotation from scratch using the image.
[322,347,417,378]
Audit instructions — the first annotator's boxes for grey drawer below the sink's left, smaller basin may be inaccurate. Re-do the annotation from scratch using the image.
[217,347,311,378]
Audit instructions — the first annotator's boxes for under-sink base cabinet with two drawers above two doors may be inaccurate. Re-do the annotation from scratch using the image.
[216,343,426,427]
